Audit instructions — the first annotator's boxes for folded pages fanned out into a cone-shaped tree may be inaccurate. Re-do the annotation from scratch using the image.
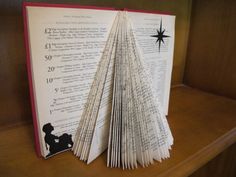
[73,12,173,169]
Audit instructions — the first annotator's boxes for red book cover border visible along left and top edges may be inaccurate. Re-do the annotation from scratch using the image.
[22,2,170,157]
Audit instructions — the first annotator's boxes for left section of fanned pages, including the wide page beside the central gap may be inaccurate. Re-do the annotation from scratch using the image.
[72,11,118,163]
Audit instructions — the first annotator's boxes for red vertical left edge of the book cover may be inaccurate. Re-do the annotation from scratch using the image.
[22,2,42,157]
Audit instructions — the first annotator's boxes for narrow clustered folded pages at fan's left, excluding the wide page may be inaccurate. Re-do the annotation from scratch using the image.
[72,13,119,162]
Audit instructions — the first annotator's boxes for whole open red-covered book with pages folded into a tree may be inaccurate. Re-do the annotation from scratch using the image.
[24,3,175,169]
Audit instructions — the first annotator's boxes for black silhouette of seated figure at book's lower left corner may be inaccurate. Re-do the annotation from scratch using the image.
[43,123,73,157]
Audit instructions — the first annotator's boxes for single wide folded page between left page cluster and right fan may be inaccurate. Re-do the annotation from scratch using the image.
[87,13,119,163]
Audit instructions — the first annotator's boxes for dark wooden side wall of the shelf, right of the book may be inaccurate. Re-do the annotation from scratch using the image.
[184,0,236,99]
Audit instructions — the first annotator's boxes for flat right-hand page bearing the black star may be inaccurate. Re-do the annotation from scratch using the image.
[128,12,175,115]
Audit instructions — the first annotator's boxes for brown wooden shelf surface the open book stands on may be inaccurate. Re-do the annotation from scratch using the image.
[0,86,236,177]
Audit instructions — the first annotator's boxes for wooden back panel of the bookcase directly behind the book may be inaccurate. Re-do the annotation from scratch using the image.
[0,0,191,128]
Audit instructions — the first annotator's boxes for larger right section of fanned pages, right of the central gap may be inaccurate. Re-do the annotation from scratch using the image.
[107,12,173,169]
